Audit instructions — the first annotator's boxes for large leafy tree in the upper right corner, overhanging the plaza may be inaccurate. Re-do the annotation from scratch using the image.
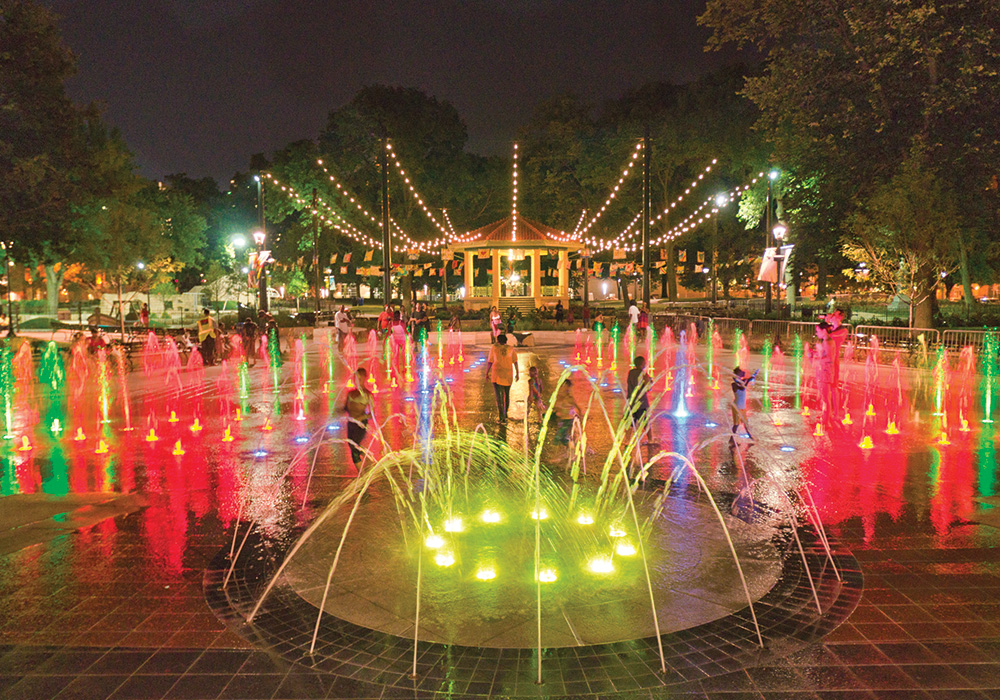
[699,0,1000,326]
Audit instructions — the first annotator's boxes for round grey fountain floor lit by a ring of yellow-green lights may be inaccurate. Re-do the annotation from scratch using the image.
[284,492,781,648]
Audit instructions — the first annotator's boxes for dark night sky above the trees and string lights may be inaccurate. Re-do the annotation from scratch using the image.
[48,0,744,180]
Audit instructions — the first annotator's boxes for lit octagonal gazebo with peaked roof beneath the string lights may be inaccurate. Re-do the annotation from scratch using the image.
[447,214,583,310]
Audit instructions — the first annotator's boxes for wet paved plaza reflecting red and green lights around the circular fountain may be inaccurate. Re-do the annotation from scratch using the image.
[0,336,1000,698]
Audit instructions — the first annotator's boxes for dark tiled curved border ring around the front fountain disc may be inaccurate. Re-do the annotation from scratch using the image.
[203,506,863,697]
